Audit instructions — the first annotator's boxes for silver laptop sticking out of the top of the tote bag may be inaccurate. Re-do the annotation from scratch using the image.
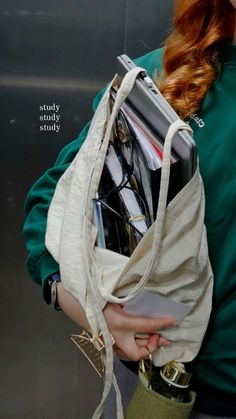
[117,54,197,189]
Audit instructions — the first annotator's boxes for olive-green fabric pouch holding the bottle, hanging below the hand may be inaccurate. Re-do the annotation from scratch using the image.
[125,373,196,419]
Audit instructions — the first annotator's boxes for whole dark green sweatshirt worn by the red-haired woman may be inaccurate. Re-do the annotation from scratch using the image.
[24,45,236,416]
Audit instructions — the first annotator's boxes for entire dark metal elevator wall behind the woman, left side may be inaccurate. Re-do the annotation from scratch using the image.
[0,0,173,419]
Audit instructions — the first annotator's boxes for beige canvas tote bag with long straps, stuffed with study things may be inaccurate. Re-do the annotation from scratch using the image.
[46,67,213,419]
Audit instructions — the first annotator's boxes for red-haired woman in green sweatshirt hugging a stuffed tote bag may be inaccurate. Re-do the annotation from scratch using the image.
[24,0,236,418]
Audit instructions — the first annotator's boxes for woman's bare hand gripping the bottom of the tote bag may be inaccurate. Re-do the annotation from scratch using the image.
[103,303,176,361]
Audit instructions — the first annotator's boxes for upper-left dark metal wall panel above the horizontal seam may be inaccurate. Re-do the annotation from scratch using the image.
[0,0,125,80]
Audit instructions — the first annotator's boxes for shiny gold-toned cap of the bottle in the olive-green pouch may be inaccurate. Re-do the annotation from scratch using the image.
[160,361,192,387]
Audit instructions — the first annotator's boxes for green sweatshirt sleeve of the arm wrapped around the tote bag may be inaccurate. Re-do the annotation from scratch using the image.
[23,50,162,297]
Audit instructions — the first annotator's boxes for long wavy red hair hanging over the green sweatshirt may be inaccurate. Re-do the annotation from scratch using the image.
[157,0,235,119]
